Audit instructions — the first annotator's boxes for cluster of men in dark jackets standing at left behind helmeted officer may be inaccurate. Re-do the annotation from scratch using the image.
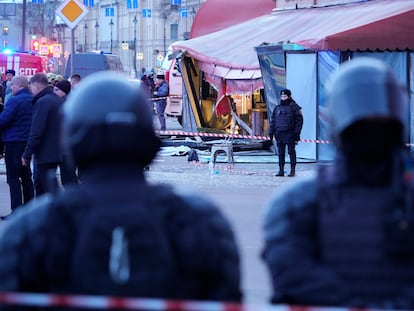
[0,70,81,219]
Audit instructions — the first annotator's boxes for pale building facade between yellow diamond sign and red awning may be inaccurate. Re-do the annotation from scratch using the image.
[76,0,205,77]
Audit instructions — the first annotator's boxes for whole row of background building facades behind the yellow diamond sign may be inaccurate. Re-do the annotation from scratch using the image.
[0,0,206,78]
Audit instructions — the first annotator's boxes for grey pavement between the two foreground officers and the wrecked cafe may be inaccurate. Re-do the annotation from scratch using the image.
[0,147,317,303]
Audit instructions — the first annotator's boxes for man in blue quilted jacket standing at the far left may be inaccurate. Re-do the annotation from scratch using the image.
[0,76,34,217]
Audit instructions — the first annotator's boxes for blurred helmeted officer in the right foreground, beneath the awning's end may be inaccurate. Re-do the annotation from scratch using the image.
[262,57,414,310]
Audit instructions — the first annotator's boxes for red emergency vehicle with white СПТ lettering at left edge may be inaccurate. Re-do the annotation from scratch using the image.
[0,53,45,77]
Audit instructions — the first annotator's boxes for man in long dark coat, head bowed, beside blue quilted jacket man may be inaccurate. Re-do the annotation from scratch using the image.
[22,73,63,196]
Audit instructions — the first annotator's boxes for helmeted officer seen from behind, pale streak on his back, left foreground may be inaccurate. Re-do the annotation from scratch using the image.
[0,73,242,308]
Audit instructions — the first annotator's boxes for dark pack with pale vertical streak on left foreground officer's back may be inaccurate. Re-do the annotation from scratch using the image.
[61,185,184,297]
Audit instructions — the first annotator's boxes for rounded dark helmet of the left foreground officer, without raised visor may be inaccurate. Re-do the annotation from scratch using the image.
[63,72,160,166]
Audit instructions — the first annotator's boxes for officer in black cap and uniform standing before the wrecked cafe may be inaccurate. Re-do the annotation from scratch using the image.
[269,89,303,177]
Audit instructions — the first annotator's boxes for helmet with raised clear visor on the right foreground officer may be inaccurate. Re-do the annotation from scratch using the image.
[327,57,408,143]
